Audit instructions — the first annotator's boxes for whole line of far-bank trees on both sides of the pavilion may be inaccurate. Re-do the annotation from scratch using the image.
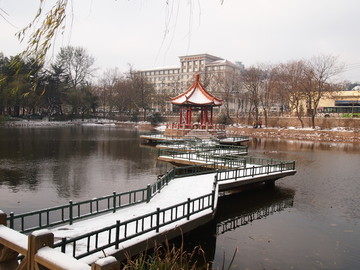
[0,46,349,127]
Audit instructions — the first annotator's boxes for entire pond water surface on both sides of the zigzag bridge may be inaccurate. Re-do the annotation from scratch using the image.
[0,126,360,269]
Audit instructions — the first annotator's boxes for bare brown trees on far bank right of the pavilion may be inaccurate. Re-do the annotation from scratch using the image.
[209,55,349,127]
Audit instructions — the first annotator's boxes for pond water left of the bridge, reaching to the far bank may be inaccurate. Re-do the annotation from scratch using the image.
[0,126,170,212]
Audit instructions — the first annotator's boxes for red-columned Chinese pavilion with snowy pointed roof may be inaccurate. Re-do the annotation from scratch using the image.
[171,74,222,129]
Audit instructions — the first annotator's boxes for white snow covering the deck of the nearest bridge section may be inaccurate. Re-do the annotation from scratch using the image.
[51,173,217,263]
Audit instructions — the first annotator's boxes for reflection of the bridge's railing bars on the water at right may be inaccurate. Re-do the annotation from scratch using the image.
[216,199,294,235]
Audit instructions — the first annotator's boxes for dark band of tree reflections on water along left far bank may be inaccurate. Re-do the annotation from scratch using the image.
[0,126,154,161]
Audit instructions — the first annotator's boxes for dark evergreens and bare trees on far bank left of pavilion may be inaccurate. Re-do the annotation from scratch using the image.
[0,46,153,120]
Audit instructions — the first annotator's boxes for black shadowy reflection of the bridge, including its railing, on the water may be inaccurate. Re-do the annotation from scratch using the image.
[183,185,295,269]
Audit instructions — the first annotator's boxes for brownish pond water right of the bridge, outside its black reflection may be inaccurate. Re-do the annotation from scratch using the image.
[215,138,360,269]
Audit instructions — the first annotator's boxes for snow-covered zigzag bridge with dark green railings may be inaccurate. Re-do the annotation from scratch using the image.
[0,138,296,269]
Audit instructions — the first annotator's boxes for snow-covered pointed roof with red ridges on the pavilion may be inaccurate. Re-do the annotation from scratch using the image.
[170,74,222,106]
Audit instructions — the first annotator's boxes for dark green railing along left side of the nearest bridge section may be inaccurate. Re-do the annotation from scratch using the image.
[7,165,218,233]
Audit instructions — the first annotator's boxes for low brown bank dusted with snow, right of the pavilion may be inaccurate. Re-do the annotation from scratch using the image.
[226,126,360,144]
